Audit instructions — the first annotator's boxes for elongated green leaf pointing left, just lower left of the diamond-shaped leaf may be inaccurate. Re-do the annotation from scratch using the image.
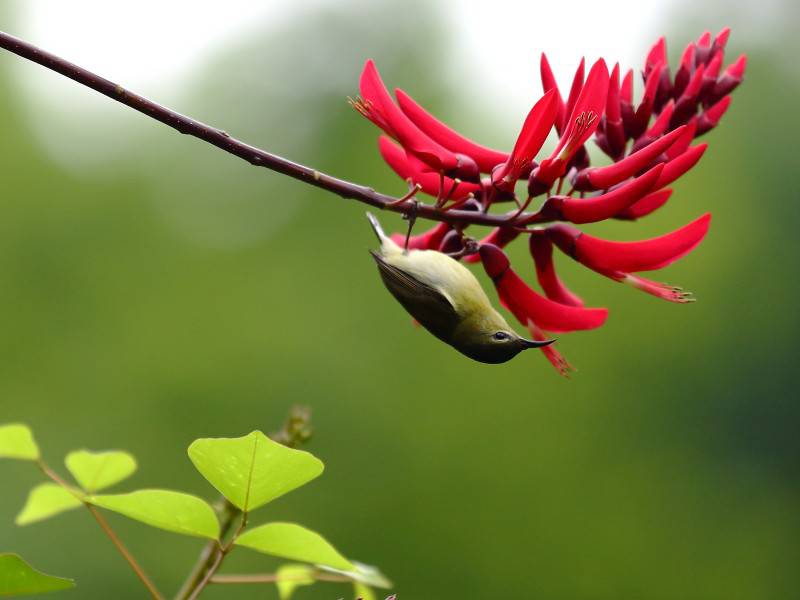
[86,490,219,540]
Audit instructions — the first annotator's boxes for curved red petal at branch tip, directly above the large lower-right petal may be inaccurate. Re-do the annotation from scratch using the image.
[542,164,664,224]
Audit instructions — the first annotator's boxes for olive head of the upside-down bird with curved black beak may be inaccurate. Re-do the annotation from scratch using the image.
[452,310,555,364]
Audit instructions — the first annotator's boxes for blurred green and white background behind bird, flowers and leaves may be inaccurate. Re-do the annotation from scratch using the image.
[0,0,800,600]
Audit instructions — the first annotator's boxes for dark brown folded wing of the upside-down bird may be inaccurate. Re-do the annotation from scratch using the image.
[370,252,459,338]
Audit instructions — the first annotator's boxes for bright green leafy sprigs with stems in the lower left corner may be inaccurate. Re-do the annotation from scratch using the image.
[0,420,391,600]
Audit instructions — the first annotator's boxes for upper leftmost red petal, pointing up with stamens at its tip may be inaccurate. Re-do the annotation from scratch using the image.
[360,60,458,171]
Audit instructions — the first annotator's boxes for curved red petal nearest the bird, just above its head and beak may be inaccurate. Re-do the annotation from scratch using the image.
[480,245,608,333]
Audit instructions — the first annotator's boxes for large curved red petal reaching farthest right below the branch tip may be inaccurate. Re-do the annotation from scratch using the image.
[545,213,711,274]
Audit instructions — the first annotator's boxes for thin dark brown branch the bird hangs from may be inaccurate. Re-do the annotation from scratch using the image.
[0,31,527,232]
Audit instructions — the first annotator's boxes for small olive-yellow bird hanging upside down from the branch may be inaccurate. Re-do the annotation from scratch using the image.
[367,213,555,364]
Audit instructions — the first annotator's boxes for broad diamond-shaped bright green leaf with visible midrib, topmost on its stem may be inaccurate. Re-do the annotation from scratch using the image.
[189,431,324,511]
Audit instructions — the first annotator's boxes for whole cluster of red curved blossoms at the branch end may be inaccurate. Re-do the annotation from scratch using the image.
[352,28,746,374]
